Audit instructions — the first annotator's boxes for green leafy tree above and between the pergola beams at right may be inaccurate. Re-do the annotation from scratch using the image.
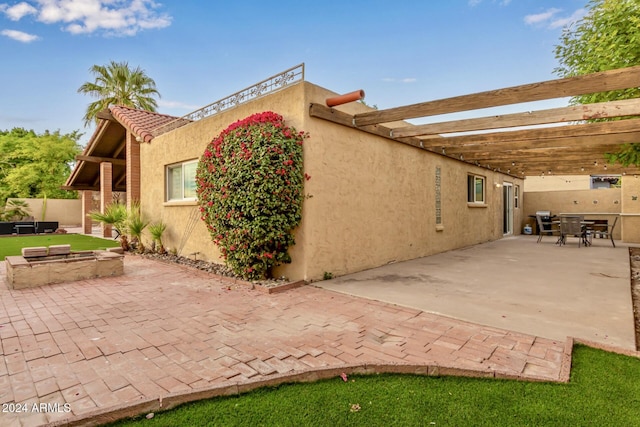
[554,0,640,165]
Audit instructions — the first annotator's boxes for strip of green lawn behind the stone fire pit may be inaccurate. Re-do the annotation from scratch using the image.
[0,234,120,260]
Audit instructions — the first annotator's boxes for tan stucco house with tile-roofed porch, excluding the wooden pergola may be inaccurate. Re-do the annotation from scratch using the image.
[66,65,522,280]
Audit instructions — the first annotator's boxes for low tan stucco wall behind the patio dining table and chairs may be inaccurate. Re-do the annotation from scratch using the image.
[522,190,622,239]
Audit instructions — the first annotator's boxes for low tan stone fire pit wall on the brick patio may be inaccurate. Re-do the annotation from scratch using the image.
[5,251,124,289]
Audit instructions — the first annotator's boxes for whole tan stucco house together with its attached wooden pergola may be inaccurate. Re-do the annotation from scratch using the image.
[66,65,640,281]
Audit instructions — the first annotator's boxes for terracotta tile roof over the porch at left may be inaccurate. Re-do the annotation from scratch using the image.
[109,105,191,142]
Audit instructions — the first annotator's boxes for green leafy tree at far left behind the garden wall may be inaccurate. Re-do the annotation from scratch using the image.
[0,128,82,204]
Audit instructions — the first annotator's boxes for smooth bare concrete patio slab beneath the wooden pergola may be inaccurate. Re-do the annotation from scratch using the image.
[316,235,635,350]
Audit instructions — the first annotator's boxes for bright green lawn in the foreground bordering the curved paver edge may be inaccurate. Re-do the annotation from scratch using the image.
[113,345,640,427]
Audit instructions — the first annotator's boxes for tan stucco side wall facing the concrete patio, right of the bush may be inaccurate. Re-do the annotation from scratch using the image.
[304,85,522,279]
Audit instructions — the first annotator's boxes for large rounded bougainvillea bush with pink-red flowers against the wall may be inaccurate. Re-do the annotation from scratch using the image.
[196,111,309,280]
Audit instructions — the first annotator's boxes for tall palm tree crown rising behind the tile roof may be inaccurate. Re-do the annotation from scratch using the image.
[78,61,160,126]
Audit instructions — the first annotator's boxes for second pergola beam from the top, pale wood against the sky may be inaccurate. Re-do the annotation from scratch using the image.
[392,99,640,138]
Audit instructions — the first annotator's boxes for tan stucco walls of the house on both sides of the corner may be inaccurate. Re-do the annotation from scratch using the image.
[141,83,523,280]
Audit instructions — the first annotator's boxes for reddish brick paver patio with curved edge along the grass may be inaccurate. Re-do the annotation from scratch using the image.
[0,256,565,426]
